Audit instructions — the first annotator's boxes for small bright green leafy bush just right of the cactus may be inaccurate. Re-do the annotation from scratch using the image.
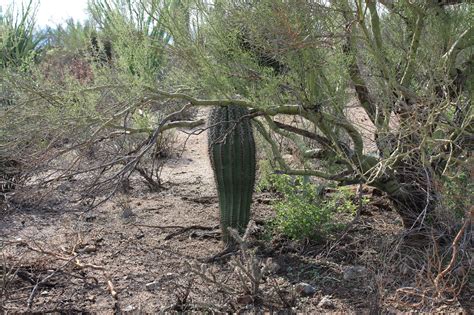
[271,175,358,240]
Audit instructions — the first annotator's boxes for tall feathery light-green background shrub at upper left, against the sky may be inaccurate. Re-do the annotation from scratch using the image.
[89,0,176,83]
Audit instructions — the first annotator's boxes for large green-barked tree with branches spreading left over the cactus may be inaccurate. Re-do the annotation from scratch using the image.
[2,0,474,239]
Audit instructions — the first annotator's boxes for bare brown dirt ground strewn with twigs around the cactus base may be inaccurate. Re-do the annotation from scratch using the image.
[0,118,469,313]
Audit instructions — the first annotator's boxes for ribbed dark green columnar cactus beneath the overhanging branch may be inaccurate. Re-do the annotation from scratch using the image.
[208,105,256,246]
